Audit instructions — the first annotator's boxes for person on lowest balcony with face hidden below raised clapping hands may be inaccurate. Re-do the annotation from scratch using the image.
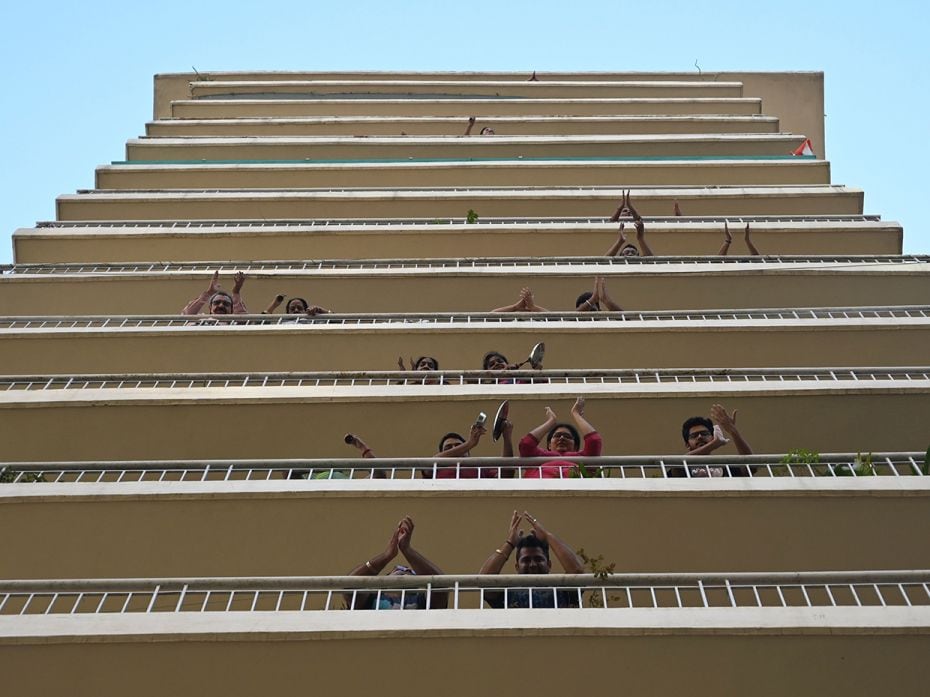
[344,516,449,610]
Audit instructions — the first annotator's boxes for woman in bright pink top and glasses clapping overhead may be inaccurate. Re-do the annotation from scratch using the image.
[520,397,603,479]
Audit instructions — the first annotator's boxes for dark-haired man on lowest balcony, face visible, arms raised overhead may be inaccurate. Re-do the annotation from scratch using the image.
[478,511,584,609]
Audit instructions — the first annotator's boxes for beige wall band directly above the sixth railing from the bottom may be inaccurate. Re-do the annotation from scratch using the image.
[50,186,863,221]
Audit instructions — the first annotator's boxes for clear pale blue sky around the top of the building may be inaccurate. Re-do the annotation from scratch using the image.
[0,0,930,262]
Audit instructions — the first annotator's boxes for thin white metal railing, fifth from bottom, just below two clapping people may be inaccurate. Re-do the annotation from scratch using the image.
[0,255,930,276]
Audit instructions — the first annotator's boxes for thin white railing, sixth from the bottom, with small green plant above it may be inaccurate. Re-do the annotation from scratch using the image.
[36,214,881,229]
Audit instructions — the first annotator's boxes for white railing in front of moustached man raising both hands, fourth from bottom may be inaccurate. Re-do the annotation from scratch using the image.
[0,305,930,331]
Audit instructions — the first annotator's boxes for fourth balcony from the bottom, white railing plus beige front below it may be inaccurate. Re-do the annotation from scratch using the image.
[0,305,930,375]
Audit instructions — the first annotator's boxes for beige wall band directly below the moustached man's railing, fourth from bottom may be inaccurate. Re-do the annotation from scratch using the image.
[0,320,930,375]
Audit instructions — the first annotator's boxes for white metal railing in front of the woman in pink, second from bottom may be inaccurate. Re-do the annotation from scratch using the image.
[0,452,930,484]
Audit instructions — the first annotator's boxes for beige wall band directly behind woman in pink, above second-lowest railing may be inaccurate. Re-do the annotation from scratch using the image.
[0,392,930,461]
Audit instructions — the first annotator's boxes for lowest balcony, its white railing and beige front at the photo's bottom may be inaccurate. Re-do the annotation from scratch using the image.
[0,572,930,695]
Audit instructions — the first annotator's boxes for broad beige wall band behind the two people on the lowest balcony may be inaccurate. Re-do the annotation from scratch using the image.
[0,478,930,576]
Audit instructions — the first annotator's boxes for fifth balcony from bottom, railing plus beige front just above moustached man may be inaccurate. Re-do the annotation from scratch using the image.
[0,256,930,316]
